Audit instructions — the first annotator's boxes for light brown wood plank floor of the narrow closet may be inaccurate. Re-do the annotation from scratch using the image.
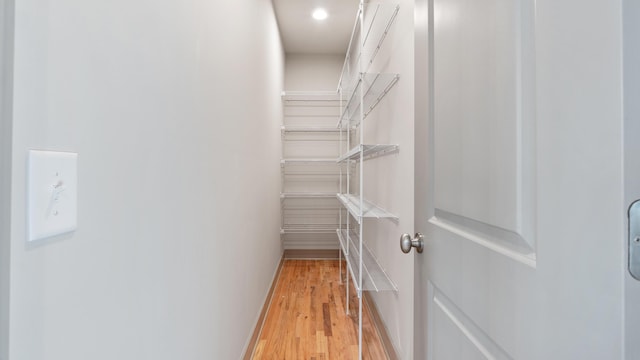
[252,260,387,360]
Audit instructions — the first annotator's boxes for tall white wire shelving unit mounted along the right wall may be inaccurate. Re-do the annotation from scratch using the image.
[336,0,400,359]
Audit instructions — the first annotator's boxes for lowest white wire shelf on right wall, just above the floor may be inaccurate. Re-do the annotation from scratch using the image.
[337,229,398,292]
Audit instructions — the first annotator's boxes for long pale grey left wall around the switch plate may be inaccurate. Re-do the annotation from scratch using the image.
[10,0,283,360]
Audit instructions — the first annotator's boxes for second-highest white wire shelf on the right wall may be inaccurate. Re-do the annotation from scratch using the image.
[338,73,400,128]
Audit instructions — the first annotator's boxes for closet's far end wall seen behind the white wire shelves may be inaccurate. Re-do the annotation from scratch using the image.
[282,53,346,250]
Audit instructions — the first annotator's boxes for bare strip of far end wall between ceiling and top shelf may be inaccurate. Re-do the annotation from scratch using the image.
[284,54,344,91]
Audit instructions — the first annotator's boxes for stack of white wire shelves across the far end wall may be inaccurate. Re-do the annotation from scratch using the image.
[280,91,344,247]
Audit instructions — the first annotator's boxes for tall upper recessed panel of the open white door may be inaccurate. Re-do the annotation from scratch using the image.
[431,0,535,265]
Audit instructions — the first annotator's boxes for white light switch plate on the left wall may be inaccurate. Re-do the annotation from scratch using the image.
[27,150,78,241]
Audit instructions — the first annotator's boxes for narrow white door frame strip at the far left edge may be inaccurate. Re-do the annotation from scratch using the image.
[0,0,13,360]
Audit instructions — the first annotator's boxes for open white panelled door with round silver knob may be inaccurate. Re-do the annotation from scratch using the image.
[414,0,626,360]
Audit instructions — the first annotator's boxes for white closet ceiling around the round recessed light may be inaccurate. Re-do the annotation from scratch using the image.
[272,0,359,55]
